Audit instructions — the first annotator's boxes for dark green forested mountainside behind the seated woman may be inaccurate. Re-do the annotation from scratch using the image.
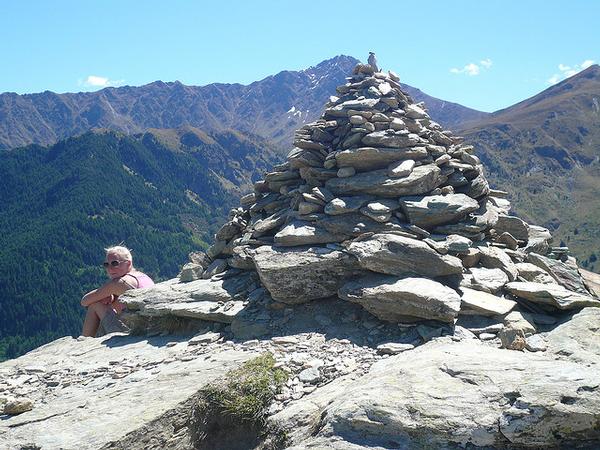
[0,128,271,360]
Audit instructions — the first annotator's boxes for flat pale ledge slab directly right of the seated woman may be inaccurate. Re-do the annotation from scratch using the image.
[120,275,251,323]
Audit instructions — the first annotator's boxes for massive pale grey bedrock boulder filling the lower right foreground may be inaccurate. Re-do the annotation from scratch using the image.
[284,340,600,449]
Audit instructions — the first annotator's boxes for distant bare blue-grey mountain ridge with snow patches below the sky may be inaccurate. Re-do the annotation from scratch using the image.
[0,55,487,151]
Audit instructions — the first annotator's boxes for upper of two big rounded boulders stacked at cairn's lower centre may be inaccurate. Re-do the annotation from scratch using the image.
[348,234,462,277]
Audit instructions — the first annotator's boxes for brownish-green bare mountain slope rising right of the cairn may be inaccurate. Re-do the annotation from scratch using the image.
[458,65,600,270]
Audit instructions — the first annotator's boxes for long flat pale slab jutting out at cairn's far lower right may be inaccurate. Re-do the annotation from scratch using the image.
[505,282,600,309]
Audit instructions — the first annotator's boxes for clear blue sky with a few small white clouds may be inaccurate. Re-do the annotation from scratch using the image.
[0,0,600,111]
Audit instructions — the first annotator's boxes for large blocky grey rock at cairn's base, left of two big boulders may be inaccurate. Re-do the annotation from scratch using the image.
[253,246,359,304]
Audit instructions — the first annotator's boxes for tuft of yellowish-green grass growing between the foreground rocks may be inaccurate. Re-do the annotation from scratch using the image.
[204,353,287,424]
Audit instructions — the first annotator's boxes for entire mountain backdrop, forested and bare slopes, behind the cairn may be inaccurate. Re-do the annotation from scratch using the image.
[0,56,600,359]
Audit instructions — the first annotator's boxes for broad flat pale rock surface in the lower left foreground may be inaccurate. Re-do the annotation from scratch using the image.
[0,335,258,450]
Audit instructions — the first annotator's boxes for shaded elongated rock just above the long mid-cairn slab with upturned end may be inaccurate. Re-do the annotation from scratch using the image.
[335,147,427,171]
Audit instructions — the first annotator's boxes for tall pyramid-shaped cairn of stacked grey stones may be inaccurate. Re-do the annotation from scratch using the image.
[180,59,600,349]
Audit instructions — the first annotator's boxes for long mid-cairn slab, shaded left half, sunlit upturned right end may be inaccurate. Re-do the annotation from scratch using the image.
[325,164,443,197]
